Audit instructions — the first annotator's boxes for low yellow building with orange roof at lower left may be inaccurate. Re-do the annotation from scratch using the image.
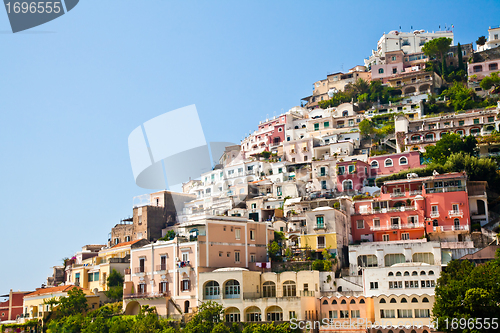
[23,286,99,321]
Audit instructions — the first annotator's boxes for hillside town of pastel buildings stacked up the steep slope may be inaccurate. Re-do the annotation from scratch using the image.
[0,27,500,333]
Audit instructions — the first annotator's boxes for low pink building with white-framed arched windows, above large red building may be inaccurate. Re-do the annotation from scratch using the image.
[368,151,421,178]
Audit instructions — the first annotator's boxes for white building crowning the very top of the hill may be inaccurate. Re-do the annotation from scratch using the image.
[365,30,453,68]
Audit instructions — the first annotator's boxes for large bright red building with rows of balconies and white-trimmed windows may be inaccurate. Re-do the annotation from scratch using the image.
[351,172,470,242]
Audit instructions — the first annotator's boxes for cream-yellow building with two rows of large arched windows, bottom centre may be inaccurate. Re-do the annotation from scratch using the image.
[199,268,319,322]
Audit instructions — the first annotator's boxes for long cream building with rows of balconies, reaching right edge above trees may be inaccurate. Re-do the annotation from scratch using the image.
[395,107,500,151]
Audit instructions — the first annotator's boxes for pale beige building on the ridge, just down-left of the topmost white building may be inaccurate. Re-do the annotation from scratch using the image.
[302,66,371,109]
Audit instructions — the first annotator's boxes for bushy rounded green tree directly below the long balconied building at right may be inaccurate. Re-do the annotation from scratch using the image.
[424,133,477,164]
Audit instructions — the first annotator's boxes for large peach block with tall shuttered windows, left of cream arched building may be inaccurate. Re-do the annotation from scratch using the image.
[124,216,274,315]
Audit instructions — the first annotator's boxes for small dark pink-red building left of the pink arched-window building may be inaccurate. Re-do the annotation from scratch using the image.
[337,160,370,192]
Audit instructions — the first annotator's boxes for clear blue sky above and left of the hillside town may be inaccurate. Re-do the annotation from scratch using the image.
[0,0,500,294]
